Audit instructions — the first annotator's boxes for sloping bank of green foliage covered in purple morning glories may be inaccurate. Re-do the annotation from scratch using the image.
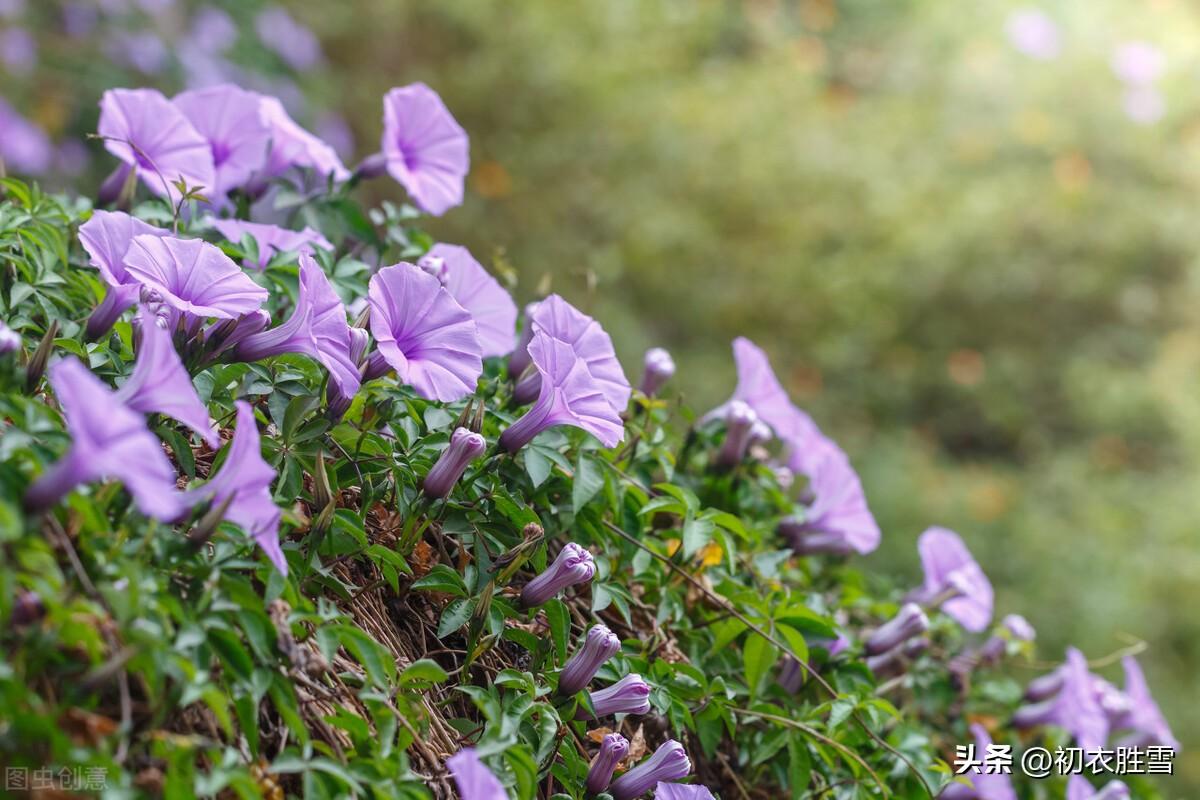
[0,84,1177,800]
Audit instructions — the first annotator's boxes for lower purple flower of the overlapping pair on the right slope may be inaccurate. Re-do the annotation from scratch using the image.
[780,439,882,555]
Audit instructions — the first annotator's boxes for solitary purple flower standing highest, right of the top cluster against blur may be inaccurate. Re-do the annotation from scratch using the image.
[380,83,470,216]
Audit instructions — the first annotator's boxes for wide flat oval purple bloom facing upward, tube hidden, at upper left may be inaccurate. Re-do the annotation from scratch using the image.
[125,234,266,319]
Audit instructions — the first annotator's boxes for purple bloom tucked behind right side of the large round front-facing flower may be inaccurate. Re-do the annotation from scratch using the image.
[416,245,517,359]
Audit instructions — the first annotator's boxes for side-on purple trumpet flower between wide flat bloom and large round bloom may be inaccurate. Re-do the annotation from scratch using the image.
[234,253,360,397]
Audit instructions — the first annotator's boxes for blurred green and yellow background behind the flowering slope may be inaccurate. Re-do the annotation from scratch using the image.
[0,0,1200,798]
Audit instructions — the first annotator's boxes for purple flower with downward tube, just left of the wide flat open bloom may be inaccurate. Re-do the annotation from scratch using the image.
[79,210,170,338]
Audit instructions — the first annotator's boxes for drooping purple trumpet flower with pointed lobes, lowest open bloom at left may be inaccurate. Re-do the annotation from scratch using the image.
[185,401,288,575]
